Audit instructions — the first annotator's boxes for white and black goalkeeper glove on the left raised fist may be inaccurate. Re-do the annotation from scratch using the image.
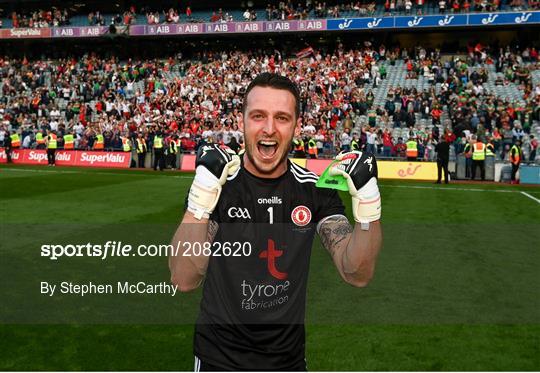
[188,144,240,220]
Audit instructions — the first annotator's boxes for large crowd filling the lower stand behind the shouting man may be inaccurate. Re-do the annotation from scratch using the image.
[0,43,540,160]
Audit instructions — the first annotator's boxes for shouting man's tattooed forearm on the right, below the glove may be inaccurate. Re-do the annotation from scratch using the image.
[319,215,382,287]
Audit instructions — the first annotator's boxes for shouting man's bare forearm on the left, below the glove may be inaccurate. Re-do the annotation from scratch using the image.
[169,211,219,292]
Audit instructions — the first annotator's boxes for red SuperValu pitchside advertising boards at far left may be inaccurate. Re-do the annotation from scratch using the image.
[0,148,131,168]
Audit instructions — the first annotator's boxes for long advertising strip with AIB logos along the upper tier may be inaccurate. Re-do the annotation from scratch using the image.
[0,11,540,39]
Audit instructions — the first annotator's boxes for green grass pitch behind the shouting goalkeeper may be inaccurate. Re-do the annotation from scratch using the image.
[0,166,540,371]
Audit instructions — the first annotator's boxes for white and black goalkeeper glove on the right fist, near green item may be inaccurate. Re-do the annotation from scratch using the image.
[329,151,381,223]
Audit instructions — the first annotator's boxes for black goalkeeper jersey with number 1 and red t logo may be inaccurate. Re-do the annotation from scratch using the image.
[194,161,344,370]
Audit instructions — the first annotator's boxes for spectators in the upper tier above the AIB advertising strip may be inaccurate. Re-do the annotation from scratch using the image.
[0,0,540,27]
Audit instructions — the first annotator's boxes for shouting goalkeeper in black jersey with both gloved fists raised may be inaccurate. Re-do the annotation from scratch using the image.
[169,73,382,371]
